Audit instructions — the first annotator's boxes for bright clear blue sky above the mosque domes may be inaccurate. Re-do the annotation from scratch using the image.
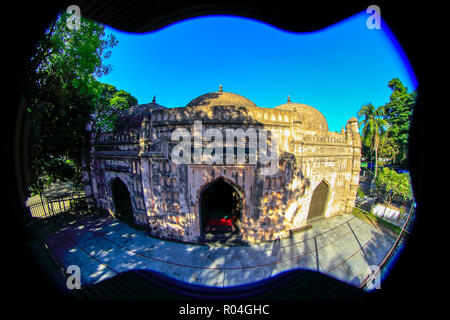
[98,11,418,131]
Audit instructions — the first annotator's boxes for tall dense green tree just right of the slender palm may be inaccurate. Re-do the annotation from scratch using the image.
[384,78,417,163]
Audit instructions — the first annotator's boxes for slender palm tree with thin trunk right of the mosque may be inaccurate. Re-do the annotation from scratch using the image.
[358,103,388,193]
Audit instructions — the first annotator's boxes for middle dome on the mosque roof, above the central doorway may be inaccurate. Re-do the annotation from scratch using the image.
[186,91,257,107]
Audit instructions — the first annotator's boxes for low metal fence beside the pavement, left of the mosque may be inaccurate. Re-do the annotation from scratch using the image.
[26,191,87,218]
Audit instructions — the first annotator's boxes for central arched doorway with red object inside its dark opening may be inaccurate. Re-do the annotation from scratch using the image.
[200,178,243,233]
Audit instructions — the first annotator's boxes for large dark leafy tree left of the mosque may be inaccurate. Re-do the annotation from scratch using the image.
[23,13,117,192]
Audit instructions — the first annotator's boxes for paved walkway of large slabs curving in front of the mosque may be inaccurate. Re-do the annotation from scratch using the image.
[41,214,395,287]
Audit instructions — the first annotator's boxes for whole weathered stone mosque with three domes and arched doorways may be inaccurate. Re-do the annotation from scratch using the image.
[83,86,361,243]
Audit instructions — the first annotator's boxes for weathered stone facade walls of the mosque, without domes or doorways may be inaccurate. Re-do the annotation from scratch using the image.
[84,107,361,242]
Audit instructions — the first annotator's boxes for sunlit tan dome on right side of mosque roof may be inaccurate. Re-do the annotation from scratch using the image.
[275,98,328,131]
